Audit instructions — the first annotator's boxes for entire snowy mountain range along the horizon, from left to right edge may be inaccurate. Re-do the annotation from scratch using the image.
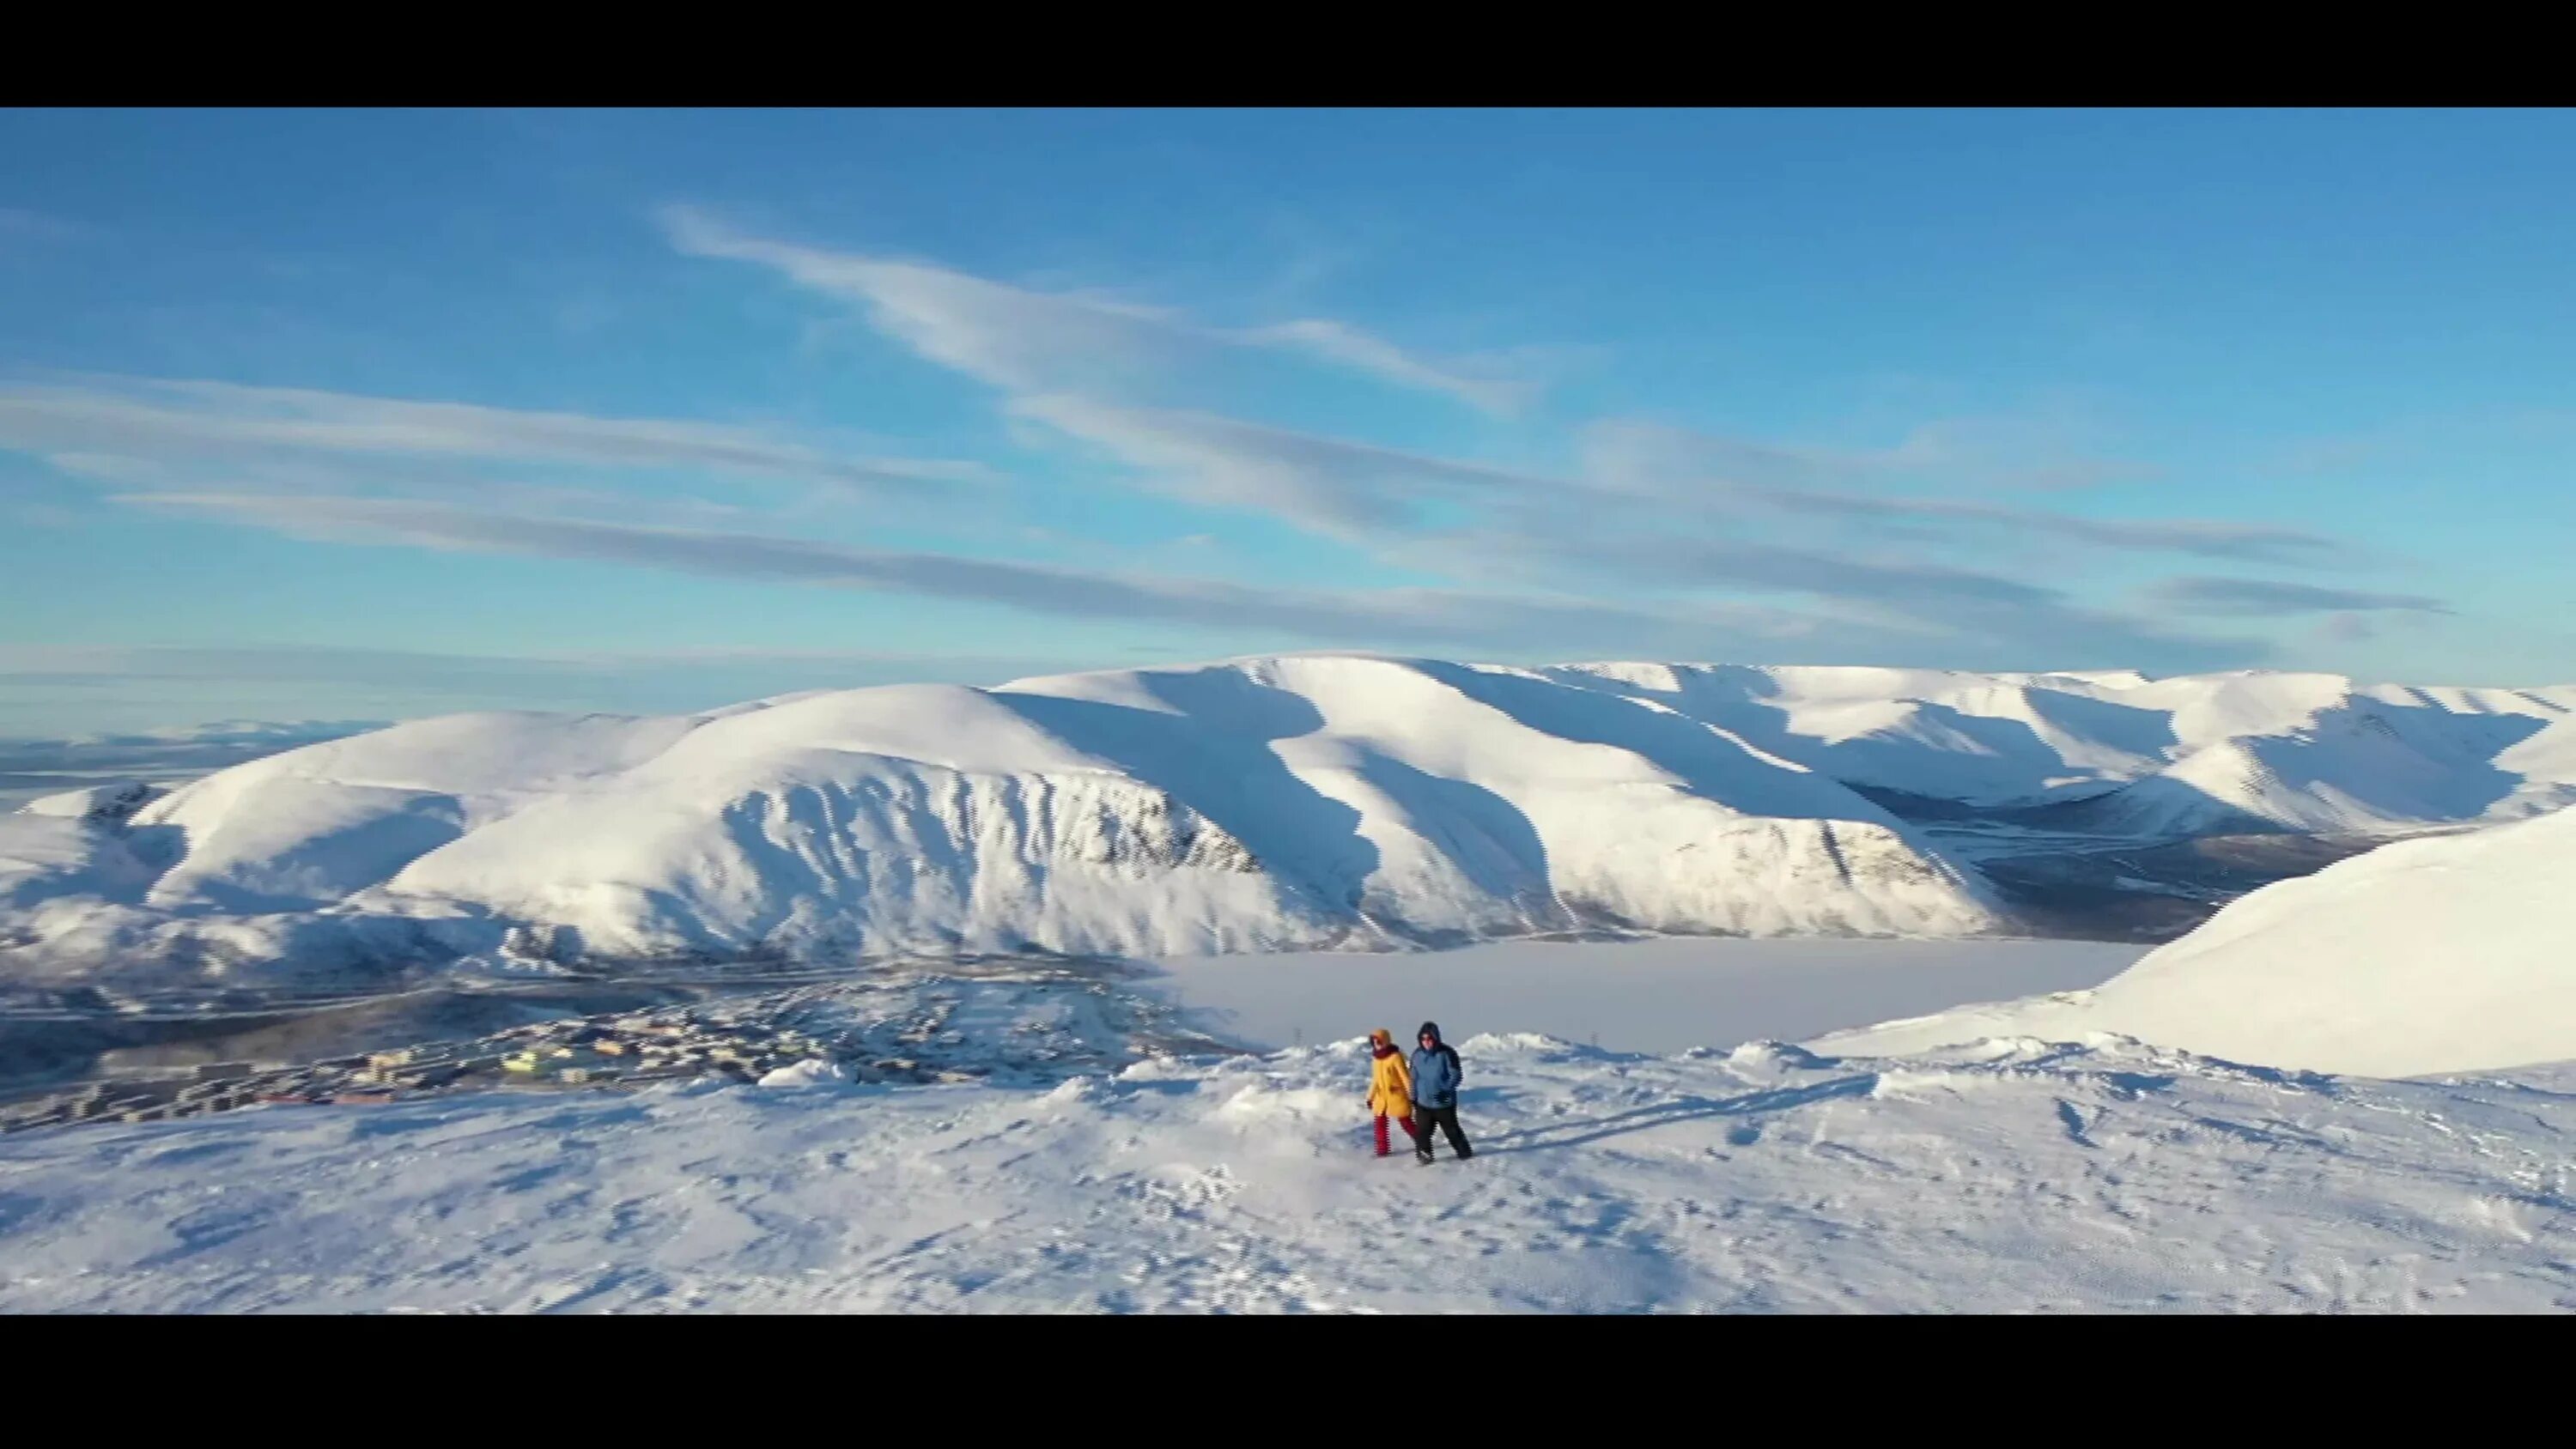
[0,657,2576,980]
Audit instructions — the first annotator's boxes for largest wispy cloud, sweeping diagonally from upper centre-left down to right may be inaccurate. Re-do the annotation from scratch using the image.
[665,209,2342,652]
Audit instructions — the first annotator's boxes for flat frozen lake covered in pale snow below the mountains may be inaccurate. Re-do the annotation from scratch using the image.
[1144,939,2151,1055]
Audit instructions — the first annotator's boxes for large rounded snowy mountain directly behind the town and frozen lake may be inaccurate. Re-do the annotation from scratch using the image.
[0,657,1996,975]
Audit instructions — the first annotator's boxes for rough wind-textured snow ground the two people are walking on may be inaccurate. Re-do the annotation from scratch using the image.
[0,1034,2576,1313]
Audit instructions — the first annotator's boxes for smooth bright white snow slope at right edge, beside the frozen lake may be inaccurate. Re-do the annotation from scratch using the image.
[1816,810,2576,1076]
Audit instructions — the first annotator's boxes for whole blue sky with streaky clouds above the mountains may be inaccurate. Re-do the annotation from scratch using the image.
[0,111,2576,736]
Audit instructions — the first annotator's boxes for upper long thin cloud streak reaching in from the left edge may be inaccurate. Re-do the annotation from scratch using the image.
[0,379,987,494]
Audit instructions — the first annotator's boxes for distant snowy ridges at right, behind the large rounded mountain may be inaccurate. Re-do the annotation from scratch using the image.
[1548,664,2576,836]
